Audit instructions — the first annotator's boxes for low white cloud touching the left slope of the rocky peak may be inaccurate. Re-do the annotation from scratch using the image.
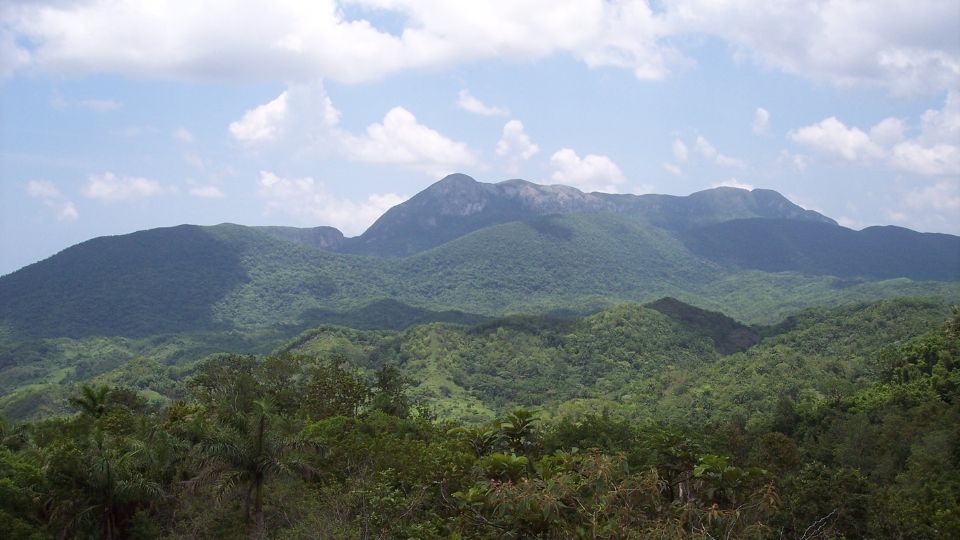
[258,171,406,236]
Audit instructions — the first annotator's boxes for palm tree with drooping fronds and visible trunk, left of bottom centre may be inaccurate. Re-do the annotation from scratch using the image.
[187,399,315,538]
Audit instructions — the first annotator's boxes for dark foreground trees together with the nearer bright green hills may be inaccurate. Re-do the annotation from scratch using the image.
[0,300,960,539]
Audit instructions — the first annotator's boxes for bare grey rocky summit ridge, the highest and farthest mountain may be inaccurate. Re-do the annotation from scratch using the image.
[339,174,836,257]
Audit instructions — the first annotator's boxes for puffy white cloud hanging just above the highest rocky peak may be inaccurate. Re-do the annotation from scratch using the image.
[341,107,477,176]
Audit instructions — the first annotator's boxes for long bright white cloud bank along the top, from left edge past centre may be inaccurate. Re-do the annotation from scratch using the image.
[5,0,671,83]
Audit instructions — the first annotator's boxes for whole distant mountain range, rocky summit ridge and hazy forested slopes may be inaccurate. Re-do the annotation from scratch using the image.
[0,174,960,337]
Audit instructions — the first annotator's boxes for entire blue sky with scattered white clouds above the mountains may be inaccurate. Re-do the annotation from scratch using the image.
[0,0,960,275]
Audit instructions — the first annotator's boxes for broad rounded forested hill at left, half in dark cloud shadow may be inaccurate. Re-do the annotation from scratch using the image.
[0,221,388,337]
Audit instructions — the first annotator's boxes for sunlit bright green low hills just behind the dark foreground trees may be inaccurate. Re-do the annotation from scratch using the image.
[282,299,950,422]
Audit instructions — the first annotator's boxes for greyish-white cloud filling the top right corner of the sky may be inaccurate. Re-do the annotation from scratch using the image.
[666,0,960,94]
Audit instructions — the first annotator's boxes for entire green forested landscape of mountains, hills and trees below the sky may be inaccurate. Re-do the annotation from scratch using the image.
[0,175,960,539]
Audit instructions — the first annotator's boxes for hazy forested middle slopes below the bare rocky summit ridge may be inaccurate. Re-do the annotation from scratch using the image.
[0,213,960,338]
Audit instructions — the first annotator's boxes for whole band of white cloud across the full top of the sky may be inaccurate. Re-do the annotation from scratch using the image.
[0,0,960,93]
